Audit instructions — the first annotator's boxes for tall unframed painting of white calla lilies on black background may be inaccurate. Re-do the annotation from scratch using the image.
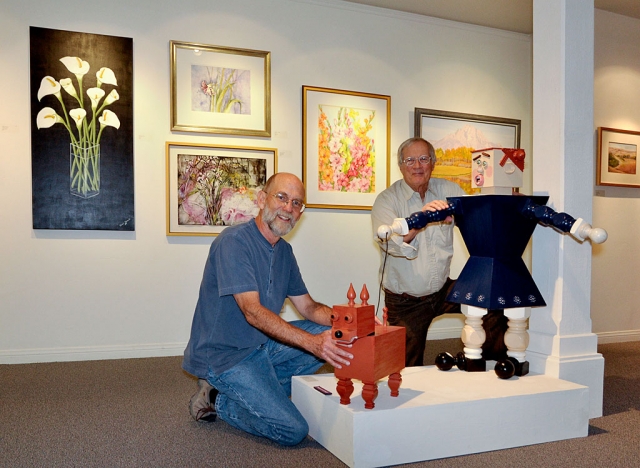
[30,27,134,230]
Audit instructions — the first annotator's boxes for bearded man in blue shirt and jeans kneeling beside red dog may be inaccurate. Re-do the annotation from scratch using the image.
[182,173,353,445]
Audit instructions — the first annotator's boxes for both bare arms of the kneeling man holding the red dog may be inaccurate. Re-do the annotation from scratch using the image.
[233,291,353,369]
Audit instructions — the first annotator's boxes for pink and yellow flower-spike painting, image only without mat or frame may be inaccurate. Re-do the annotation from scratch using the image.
[318,105,376,193]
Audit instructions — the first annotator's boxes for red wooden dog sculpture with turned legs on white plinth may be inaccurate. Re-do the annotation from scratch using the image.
[331,284,406,409]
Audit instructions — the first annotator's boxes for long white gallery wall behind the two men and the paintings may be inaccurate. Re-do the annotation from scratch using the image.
[0,0,528,363]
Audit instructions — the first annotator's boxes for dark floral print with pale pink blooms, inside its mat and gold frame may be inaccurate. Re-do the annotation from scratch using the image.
[177,154,267,226]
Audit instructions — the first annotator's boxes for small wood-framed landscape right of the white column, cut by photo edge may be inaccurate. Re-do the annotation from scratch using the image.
[596,127,640,187]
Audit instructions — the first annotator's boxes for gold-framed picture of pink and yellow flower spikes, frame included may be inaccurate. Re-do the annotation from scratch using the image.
[302,86,391,210]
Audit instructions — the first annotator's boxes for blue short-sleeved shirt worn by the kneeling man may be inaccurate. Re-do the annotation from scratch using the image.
[182,220,307,378]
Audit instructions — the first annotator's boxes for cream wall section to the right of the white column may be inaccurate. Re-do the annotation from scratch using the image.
[591,10,640,343]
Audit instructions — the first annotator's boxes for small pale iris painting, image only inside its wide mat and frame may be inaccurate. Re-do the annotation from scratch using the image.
[191,65,251,115]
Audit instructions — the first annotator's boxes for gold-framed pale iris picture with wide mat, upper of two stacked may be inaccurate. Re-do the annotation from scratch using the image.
[170,41,271,137]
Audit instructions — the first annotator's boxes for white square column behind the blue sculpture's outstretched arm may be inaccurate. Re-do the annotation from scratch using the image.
[527,0,604,418]
